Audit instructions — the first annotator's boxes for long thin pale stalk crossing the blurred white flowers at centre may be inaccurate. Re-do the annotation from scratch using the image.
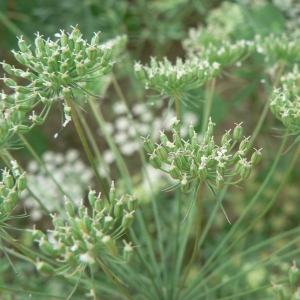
[111,73,169,284]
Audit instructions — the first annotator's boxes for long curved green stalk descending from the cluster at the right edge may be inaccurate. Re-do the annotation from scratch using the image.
[184,131,288,293]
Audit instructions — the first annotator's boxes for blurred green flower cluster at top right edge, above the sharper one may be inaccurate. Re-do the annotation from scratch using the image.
[255,31,300,64]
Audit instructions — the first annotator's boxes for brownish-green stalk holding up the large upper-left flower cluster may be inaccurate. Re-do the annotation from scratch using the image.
[65,97,109,200]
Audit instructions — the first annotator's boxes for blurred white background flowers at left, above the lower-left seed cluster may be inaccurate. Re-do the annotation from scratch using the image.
[22,149,93,221]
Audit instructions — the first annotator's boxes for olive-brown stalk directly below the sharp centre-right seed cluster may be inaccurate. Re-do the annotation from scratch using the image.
[179,181,203,290]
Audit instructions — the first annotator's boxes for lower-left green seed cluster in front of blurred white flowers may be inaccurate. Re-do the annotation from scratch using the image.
[29,183,138,274]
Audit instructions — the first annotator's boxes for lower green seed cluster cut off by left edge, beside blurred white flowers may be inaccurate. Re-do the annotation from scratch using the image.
[0,161,27,223]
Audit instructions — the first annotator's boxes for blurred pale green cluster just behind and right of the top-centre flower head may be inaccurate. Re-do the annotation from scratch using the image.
[183,27,254,68]
